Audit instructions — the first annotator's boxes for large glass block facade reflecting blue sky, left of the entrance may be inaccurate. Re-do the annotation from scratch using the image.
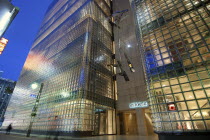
[3,0,116,135]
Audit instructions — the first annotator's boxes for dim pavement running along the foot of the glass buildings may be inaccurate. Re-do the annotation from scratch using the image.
[0,134,158,140]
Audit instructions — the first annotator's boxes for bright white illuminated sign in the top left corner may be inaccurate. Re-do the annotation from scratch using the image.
[0,0,19,38]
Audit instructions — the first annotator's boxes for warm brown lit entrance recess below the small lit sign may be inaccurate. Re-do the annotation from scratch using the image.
[117,108,156,136]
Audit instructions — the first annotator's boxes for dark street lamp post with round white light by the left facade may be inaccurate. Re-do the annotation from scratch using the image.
[26,83,44,137]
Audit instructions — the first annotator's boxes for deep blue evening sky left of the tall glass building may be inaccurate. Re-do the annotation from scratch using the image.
[0,0,52,81]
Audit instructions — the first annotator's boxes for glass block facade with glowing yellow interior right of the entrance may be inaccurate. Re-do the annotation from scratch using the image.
[131,0,210,138]
